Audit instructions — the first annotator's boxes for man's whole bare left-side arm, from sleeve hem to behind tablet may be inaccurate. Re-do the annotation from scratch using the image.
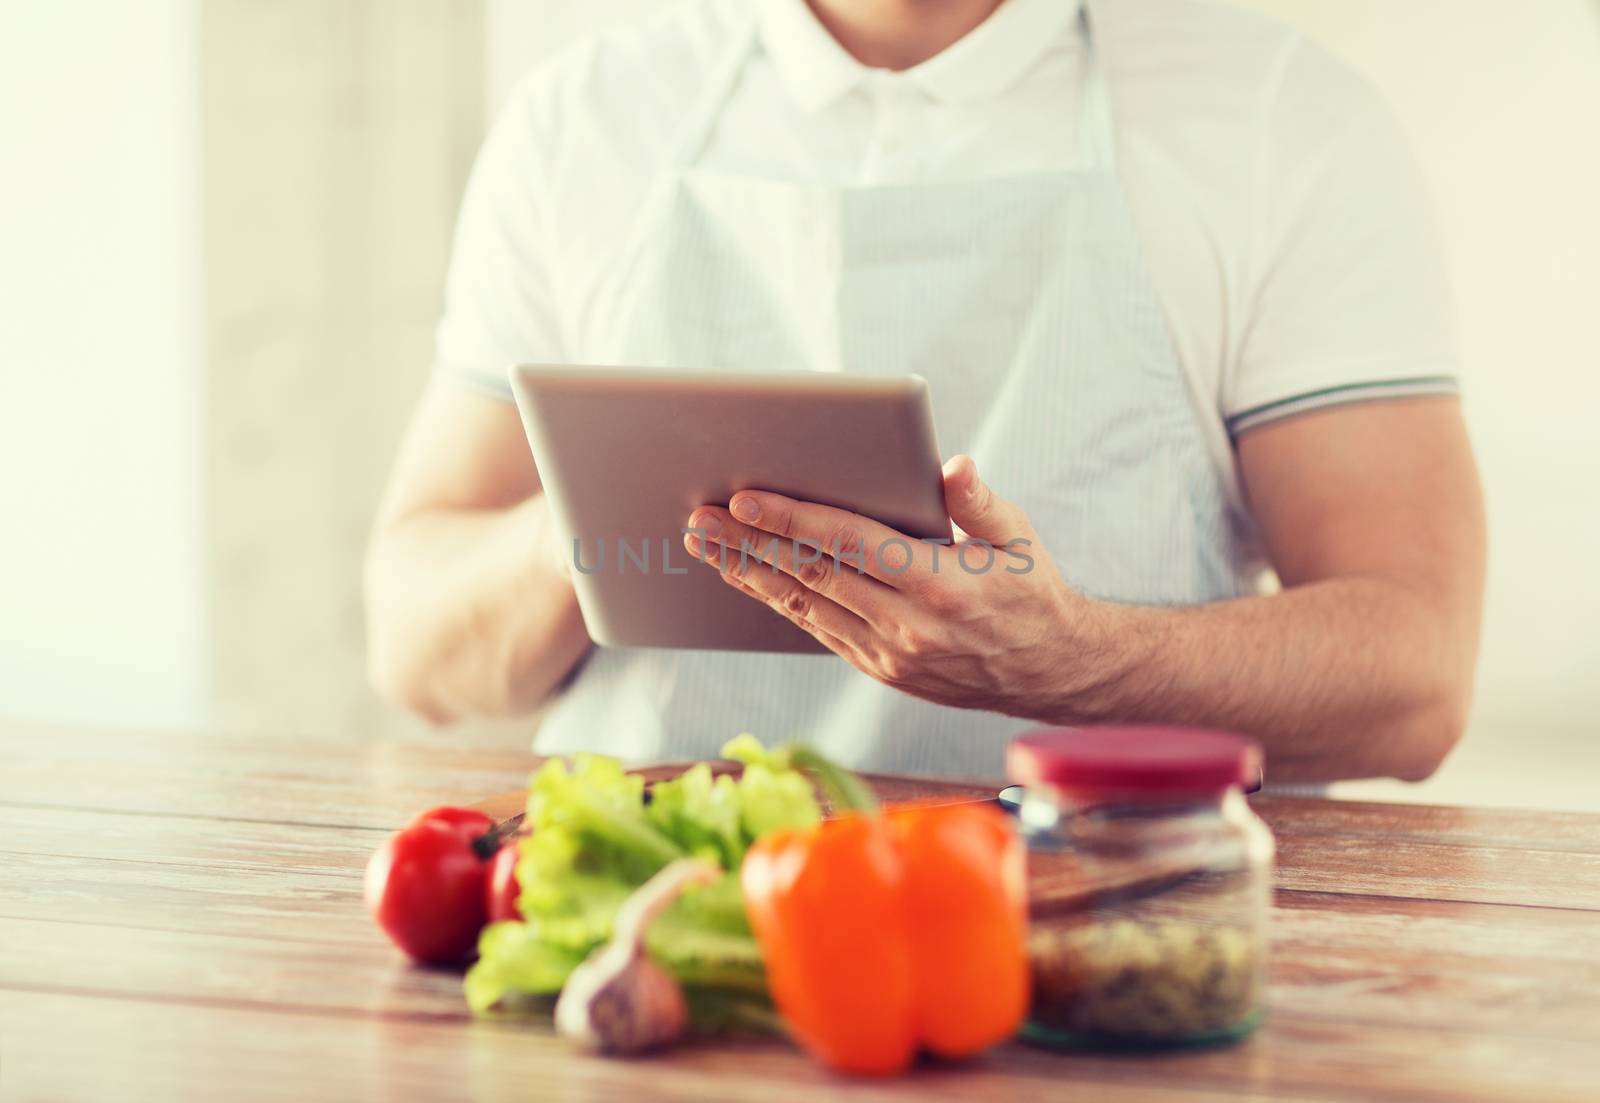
[366,384,589,722]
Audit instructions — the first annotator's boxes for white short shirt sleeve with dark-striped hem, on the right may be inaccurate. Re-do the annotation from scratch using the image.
[1221,45,1458,435]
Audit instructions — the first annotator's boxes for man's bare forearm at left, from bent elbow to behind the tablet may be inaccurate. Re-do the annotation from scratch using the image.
[366,495,589,722]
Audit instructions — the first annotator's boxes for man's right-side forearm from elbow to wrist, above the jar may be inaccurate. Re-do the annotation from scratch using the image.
[1043,578,1475,780]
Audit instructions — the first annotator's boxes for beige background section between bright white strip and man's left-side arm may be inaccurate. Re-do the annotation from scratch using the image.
[195,0,480,746]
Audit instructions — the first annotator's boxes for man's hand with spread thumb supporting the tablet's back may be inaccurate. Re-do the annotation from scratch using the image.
[685,456,1096,716]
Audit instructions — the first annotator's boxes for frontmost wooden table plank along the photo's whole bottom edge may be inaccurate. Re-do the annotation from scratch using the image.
[0,993,1594,1103]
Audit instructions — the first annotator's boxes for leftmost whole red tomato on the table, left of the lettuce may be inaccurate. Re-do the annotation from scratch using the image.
[366,813,493,962]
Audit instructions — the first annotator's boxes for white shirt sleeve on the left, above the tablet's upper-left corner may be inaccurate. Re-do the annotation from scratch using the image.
[434,83,565,400]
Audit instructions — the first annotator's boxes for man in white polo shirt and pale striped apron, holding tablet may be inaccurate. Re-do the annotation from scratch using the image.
[368,0,1483,783]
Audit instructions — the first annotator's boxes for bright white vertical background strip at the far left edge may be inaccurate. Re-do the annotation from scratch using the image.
[0,0,206,724]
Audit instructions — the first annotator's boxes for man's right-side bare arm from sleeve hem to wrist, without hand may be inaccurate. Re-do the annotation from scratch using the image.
[1066,399,1485,780]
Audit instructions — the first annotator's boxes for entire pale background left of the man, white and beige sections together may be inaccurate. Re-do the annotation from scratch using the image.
[0,0,480,744]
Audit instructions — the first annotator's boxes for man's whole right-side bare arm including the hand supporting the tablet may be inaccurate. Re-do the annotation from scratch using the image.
[688,399,1483,780]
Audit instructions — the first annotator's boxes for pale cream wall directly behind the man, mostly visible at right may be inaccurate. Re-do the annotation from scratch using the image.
[486,0,1600,805]
